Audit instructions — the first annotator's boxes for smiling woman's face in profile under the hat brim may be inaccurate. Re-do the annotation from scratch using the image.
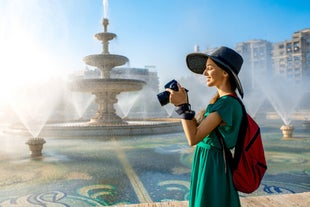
[203,58,226,87]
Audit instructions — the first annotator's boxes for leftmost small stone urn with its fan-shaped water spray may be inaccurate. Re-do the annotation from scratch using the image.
[10,80,62,157]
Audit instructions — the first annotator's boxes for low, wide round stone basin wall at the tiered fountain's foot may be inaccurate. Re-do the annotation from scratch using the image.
[4,118,183,139]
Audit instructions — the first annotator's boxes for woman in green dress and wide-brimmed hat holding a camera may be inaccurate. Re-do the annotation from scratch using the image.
[166,47,243,207]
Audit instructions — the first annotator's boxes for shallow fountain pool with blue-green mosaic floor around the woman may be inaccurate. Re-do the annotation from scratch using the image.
[0,123,310,207]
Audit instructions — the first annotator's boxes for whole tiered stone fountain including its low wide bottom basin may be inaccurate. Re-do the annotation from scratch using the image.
[62,18,182,136]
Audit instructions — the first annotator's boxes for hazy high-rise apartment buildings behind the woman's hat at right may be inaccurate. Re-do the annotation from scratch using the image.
[199,28,310,90]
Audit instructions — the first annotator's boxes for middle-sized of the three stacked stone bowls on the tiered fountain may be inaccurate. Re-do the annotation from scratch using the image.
[83,54,129,68]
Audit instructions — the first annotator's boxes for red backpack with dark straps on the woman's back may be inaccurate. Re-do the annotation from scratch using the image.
[215,96,267,193]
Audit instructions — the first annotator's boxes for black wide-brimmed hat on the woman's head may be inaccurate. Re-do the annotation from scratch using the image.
[186,47,243,98]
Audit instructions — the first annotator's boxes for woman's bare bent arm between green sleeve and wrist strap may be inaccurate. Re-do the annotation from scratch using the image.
[182,112,222,146]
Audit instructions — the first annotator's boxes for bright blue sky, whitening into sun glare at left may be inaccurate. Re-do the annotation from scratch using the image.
[0,0,310,87]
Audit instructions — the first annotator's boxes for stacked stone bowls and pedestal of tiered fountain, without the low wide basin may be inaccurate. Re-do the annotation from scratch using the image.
[71,18,144,125]
